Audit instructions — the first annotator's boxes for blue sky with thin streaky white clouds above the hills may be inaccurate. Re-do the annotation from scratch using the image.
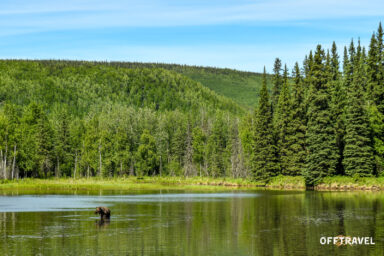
[0,0,384,72]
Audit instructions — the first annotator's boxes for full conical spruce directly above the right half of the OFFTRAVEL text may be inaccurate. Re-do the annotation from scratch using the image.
[343,47,374,176]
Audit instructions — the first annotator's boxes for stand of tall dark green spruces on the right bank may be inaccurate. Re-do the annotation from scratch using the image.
[243,24,384,185]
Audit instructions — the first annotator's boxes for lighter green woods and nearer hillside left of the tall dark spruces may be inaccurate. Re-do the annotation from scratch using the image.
[0,61,249,178]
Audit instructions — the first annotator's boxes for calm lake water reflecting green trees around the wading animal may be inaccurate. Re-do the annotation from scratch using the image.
[0,190,384,256]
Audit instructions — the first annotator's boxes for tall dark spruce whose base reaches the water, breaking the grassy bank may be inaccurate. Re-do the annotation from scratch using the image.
[303,45,338,185]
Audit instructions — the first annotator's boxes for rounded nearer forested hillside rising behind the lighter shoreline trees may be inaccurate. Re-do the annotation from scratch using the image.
[0,60,242,115]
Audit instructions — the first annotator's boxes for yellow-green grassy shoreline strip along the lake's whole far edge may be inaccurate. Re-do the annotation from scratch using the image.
[0,176,384,191]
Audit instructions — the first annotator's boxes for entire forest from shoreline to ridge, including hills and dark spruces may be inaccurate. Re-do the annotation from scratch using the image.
[0,24,384,185]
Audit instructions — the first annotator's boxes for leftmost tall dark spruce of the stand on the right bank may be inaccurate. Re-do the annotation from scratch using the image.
[251,68,278,181]
